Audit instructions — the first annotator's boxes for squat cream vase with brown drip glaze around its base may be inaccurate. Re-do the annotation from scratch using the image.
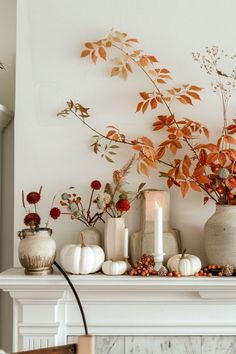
[18,228,56,275]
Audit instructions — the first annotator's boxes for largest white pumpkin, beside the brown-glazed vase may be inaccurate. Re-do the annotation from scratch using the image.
[60,233,105,274]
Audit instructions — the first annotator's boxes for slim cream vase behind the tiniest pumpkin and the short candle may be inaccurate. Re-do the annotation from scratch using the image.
[104,218,125,261]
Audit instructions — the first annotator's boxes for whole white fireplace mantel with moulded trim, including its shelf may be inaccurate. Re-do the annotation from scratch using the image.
[0,268,236,350]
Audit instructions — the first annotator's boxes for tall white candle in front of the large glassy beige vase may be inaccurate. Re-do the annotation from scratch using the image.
[154,202,163,255]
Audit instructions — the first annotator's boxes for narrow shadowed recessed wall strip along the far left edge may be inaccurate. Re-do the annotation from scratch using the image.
[0,0,16,352]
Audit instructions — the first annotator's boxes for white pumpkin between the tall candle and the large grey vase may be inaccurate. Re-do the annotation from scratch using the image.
[167,249,202,276]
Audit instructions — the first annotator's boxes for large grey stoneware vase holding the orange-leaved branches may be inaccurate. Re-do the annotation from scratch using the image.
[204,205,236,269]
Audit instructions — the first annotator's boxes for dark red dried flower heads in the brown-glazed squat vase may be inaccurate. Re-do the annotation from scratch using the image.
[22,187,61,230]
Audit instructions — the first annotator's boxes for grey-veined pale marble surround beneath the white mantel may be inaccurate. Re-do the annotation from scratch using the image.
[68,336,236,354]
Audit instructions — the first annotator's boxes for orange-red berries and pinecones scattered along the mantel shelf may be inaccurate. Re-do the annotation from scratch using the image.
[129,254,234,278]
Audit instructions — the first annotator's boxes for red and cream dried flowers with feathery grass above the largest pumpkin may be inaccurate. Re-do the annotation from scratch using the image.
[60,158,145,221]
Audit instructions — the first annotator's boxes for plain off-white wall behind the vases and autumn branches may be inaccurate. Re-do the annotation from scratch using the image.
[15,0,236,264]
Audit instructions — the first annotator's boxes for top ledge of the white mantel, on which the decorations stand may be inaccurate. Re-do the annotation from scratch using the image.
[0,268,236,300]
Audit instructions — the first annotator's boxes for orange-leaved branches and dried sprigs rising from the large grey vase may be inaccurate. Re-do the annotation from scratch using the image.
[58,30,236,205]
